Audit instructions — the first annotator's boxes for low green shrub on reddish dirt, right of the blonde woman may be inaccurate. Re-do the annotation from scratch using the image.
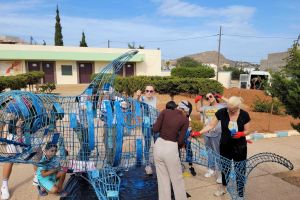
[252,97,283,115]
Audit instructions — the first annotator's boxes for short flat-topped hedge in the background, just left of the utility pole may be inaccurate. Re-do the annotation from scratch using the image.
[171,66,215,78]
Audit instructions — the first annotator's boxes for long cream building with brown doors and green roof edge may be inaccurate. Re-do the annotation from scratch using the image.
[0,44,166,84]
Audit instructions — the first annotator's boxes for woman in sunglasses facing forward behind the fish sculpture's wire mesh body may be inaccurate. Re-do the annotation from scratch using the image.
[136,85,157,175]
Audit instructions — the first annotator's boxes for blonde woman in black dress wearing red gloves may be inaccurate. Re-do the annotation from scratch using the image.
[192,96,251,198]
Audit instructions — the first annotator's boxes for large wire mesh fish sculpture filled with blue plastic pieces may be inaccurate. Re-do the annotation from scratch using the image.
[0,48,293,199]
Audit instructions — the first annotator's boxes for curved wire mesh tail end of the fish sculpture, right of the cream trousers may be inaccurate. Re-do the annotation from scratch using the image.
[180,138,294,199]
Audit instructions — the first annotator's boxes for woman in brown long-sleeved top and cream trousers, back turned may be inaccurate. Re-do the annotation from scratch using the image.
[152,104,189,200]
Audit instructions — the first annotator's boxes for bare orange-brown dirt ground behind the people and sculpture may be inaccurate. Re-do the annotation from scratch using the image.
[54,84,300,132]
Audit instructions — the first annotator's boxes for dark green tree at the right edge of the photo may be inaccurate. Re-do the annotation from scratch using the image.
[268,39,300,131]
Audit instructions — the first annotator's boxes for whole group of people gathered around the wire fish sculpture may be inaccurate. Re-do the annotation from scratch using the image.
[1,85,251,200]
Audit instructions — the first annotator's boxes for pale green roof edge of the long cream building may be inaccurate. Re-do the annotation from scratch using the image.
[0,49,144,62]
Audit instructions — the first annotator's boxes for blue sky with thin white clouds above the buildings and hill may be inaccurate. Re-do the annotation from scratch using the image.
[0,0,300,63]
